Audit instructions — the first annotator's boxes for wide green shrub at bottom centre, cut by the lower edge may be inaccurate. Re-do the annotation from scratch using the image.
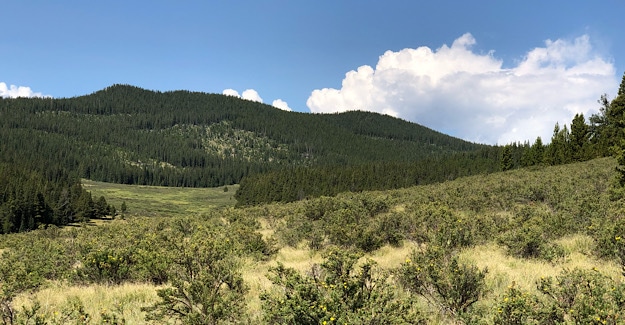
[260,249,425,324]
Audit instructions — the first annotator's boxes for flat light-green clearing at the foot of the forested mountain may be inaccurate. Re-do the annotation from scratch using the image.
[82,179,239,216]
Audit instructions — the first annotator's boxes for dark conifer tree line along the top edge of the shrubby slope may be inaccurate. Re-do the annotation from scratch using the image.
[236,75,625,205]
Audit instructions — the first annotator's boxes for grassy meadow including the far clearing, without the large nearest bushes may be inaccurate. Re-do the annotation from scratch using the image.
[0,159,625,324]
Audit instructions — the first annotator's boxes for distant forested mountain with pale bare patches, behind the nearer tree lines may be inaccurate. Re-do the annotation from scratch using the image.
[0,85,485,187]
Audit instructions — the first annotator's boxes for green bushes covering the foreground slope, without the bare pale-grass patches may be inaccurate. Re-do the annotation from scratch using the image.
[0,158,625,324]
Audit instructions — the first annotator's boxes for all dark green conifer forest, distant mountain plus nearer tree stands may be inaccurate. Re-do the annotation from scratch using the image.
[0,72,625,227]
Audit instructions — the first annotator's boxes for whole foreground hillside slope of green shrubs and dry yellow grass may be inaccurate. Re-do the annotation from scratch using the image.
[0,158,625,324]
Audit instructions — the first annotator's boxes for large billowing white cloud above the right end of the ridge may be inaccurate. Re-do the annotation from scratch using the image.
[306,34,617,144]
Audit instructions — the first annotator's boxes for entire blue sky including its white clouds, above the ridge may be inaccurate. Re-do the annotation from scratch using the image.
[0,0,625,144]
